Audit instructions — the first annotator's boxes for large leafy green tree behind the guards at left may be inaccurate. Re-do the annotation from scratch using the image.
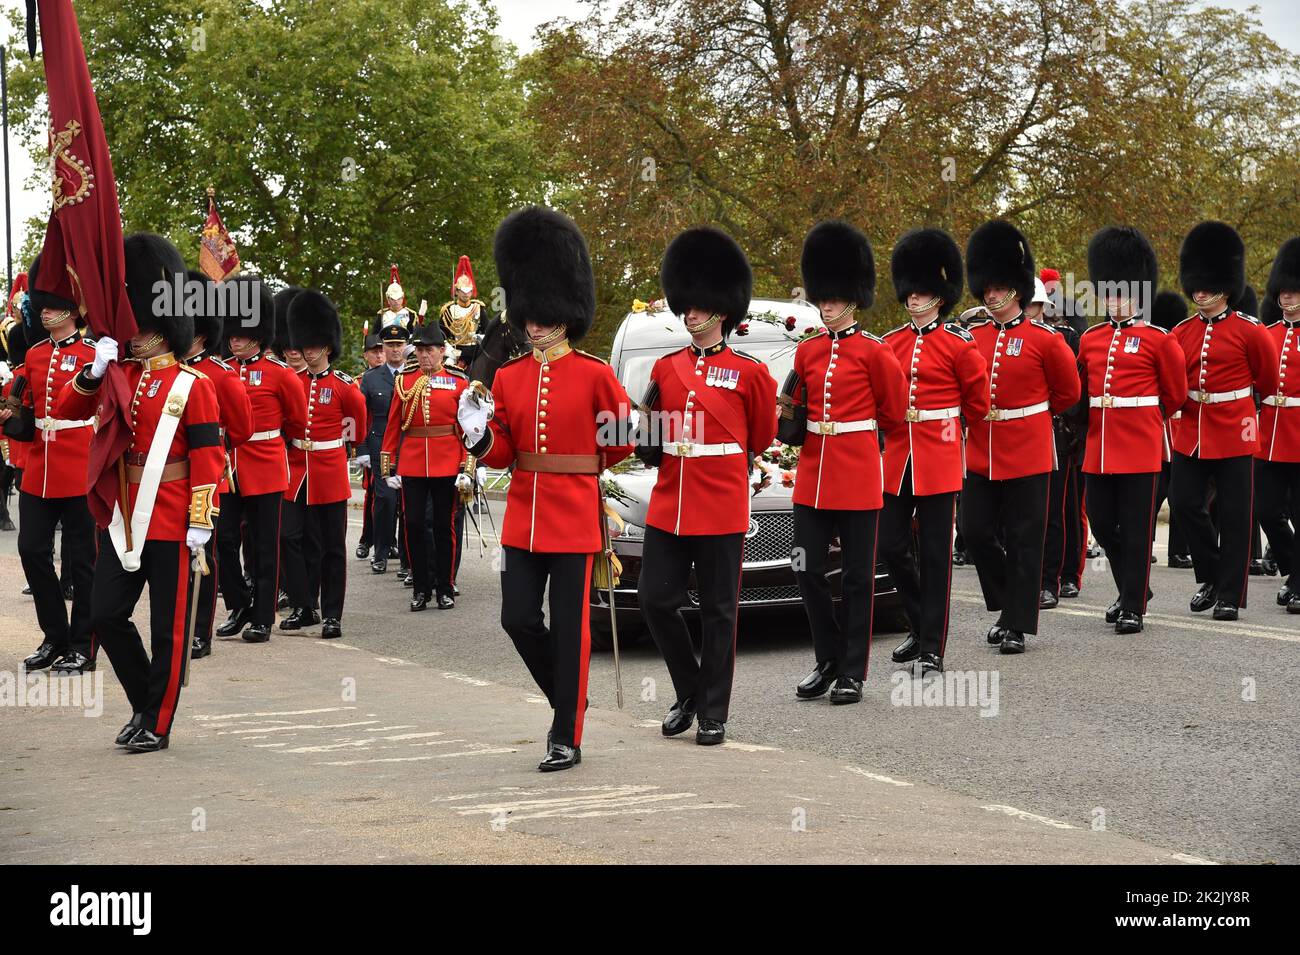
[10,0,538,361]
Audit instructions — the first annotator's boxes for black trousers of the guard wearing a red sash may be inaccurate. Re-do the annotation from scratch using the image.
[637,528,745,722]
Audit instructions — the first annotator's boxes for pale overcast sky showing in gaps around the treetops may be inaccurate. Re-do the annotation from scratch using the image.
[0,0,1300,281]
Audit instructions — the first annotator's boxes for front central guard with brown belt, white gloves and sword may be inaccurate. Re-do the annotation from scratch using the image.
[456,205,632,772]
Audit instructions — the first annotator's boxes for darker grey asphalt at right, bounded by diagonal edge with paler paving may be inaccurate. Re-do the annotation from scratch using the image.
[345,511,1300,863]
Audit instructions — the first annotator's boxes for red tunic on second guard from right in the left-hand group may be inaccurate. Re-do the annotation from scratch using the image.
[230,352,307,496]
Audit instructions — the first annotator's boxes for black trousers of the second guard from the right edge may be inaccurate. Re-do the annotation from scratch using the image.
[1169,452,1255,607]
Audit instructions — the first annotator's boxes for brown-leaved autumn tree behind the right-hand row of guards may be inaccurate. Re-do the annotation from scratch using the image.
[523,0,1300,337]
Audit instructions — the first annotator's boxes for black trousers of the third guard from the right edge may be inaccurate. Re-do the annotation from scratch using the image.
[1087,472,1160,613]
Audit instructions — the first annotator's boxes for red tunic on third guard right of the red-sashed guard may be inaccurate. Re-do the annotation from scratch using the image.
[966,314,1079,481]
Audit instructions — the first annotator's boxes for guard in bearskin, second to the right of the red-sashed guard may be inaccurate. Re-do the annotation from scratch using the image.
[880,229,988,674]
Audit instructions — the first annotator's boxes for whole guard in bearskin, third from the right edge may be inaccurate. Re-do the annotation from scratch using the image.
[1079,226,1187,634]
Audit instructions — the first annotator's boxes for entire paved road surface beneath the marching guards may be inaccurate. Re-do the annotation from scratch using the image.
[0,501,1300,863]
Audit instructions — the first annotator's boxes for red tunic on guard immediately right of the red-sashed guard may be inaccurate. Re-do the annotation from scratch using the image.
[794,325,907,511]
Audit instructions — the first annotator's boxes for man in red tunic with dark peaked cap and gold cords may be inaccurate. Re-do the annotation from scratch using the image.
[380,324,469,612]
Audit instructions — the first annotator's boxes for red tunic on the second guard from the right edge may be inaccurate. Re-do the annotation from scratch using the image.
[1171,309,1278,460]
